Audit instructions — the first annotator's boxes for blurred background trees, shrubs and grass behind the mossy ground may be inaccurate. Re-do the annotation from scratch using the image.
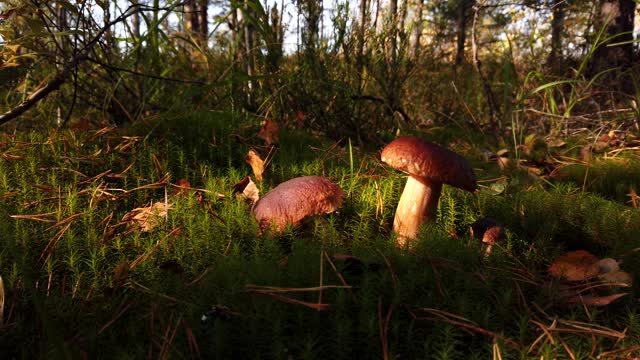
[0,0,640,146]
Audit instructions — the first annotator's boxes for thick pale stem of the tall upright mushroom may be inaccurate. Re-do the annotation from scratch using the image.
[393,175,442,246]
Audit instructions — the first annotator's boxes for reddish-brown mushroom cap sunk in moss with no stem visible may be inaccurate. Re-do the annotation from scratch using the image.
[251,176,344,234]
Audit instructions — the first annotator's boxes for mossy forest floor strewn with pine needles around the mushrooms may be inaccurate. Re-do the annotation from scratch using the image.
[0,112,640,359]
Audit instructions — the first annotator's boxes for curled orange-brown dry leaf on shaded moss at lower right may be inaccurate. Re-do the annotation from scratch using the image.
[548,250,600,281]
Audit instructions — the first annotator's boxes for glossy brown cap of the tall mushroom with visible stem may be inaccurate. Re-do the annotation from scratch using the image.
[381,136,477,192]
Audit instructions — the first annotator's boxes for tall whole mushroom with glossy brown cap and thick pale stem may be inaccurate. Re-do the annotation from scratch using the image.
[381,136,477,246]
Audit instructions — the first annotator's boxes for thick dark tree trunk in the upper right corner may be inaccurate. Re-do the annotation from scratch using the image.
[588,0,636,91]
